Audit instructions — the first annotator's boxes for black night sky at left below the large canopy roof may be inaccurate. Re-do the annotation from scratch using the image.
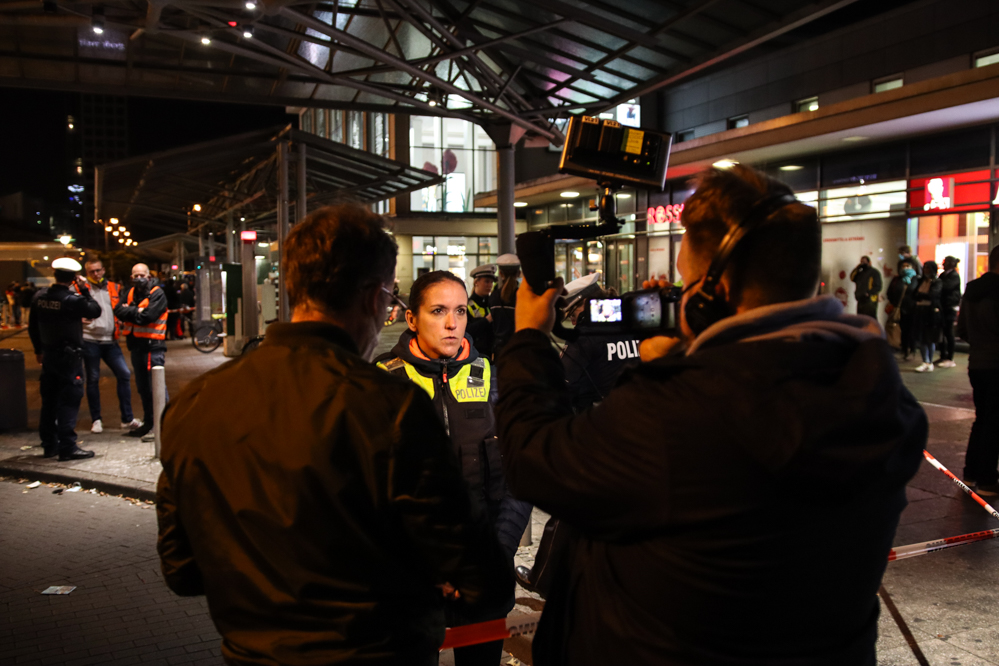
[0,88,296,202]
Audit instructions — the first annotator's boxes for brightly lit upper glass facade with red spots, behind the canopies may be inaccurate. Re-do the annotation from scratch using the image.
[409,116,496,213]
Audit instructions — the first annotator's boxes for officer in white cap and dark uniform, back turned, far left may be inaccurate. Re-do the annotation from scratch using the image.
[28,257,101,460]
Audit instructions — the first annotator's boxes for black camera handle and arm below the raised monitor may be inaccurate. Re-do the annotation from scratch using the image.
[517,182,621,342]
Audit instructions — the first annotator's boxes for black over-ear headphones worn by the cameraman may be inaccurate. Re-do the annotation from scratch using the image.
[683,194,798,335]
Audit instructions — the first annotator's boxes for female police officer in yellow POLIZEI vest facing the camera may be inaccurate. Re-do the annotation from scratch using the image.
[379,271,531,666]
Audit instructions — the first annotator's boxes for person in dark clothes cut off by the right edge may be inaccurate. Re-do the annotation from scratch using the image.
[957,247,999,497]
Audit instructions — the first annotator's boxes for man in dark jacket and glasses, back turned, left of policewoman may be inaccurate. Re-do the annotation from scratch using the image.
[157,206,513,666]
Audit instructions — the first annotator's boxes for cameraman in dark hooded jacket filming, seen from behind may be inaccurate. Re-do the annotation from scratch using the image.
[497,166,927,666]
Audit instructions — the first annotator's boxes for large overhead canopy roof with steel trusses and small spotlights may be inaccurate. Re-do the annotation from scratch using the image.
[0,0,856,145]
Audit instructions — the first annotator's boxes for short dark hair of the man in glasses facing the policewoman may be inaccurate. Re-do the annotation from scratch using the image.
[283,204,399,311]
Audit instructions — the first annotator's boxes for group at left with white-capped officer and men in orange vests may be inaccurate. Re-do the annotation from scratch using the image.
[26,257,194,461]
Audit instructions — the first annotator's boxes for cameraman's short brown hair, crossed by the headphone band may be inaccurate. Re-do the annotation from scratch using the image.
[682,164,822,303]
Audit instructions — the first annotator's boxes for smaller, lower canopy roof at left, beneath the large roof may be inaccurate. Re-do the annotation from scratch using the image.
[97,127,443,236]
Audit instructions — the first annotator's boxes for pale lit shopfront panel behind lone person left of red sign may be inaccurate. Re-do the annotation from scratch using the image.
[819,219,905,325]
